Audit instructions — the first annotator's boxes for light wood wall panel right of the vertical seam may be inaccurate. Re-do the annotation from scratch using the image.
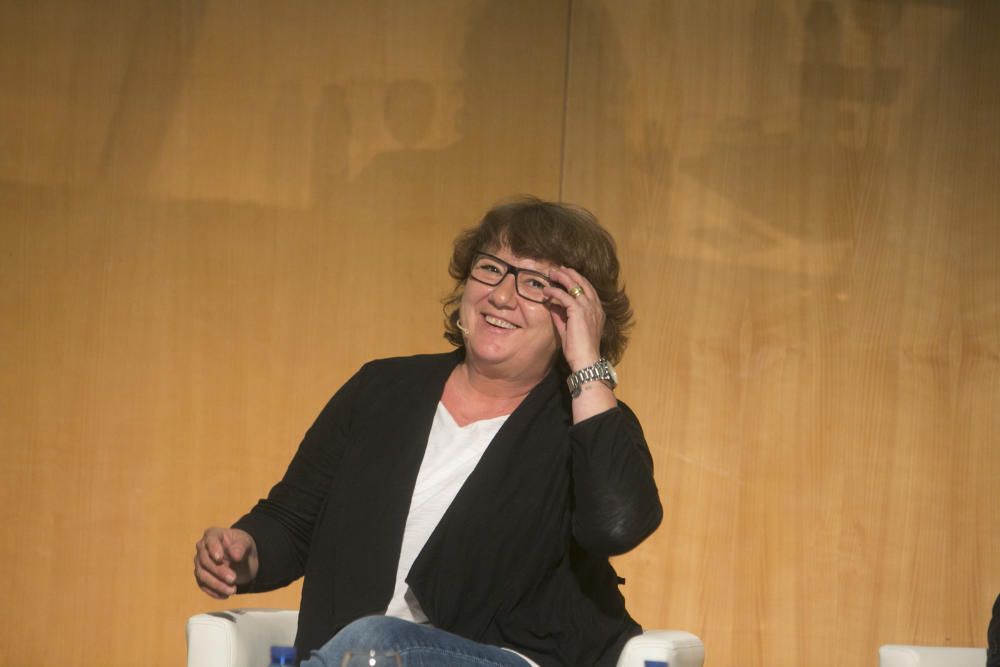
[563,0,1000,666]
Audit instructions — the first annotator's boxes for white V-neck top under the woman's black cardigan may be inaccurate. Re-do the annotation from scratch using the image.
[385,402,509,623]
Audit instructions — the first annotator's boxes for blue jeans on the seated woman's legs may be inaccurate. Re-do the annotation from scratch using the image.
[299,616,528,667]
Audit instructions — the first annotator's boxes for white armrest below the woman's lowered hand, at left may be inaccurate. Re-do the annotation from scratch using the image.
[186,609,299,667]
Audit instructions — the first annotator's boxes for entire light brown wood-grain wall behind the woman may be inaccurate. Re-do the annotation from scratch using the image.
[0,0,1000,667]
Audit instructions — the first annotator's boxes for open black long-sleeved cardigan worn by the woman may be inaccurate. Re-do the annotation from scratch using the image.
[235,351,662,667]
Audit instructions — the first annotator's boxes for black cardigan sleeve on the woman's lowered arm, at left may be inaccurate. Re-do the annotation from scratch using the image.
[233,369,364,593]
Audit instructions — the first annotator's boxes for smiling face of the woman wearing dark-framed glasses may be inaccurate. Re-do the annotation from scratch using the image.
[459,248,559,379]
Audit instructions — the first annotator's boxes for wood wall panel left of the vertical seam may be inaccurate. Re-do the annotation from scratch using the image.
[0,0,567,665]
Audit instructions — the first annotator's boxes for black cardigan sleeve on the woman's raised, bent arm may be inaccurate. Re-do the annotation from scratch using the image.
[570,402,663,556]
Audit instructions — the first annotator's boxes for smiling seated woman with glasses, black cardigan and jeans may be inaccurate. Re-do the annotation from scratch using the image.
[195,198,662,667]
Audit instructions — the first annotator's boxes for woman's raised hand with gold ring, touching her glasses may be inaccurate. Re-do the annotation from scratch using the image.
[545,266,605,371]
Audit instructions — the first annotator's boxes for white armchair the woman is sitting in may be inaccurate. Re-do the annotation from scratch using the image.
[187,609,704,667]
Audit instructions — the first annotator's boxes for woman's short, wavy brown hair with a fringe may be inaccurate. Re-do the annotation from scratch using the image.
[444,196,632,364]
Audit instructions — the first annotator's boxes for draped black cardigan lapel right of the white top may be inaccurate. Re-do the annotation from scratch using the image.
[407,371,571,636]
